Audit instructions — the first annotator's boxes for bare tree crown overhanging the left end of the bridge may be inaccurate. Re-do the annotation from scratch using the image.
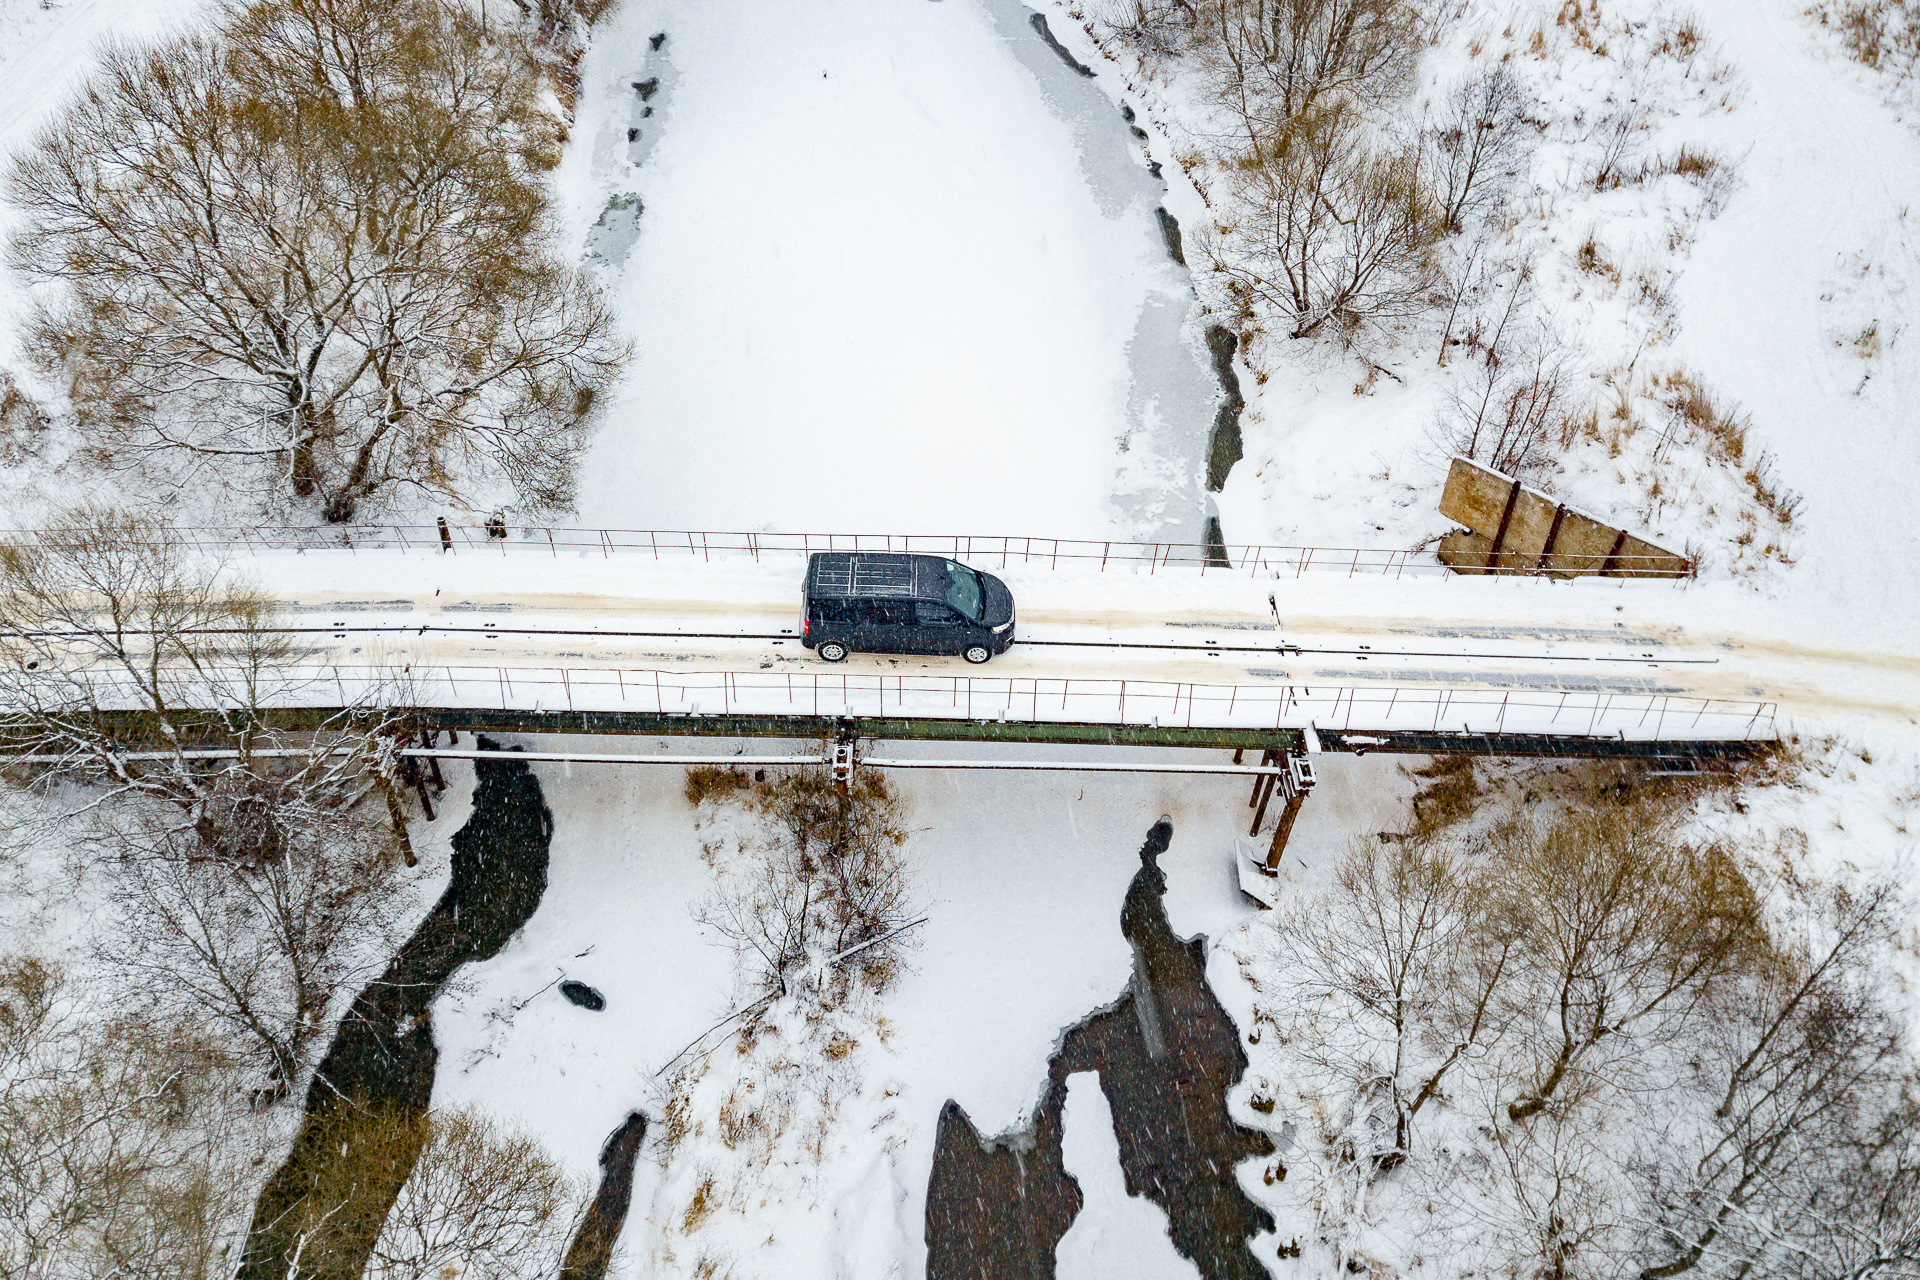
[0,507,408,832]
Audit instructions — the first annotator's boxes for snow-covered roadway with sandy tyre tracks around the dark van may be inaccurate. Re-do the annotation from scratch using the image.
[41,551,1920,737]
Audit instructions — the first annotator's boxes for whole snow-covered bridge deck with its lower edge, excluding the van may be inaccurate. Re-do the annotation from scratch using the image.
[26,526,1920,756]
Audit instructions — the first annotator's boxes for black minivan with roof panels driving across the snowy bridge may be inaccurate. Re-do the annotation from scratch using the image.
[801,551,1014,662]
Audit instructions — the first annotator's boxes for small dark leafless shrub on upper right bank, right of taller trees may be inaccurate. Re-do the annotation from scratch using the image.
[1423,63,1532,232]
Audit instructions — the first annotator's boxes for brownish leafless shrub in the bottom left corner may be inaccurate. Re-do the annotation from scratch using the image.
[0,956,250,1280]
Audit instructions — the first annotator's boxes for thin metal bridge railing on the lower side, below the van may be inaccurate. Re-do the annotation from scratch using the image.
[56,664,1776,741]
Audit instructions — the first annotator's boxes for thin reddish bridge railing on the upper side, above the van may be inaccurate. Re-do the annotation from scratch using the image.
[0,522,1689,578]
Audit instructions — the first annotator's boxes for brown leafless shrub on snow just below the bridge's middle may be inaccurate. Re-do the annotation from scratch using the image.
[689,768,912,1007]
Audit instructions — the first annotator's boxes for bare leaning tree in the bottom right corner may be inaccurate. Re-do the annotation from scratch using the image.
[1640,885,1920,1280]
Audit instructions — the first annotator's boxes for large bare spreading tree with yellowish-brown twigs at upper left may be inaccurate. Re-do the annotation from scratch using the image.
[8,0,624,520]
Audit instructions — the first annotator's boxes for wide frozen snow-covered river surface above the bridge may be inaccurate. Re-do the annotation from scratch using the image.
[561,0,1217,541]
